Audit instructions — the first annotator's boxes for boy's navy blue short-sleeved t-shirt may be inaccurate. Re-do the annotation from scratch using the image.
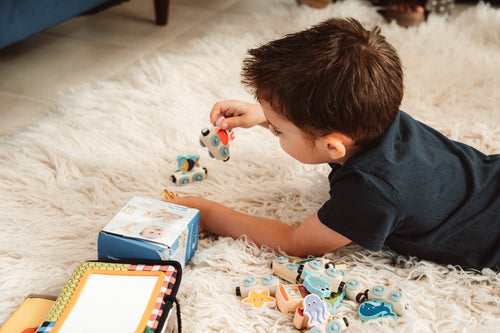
[318,111,500,269]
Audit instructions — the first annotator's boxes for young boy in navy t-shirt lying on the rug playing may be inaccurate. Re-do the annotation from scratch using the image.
[170,19,500,269]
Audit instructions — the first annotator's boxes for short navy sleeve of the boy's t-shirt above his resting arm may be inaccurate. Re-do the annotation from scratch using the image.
[318,172,404,251]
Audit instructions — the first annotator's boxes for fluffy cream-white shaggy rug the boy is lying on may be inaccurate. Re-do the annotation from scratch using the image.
[0,0,500,332]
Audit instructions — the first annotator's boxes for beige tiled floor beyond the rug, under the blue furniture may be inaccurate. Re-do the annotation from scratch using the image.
[0,0,476,136]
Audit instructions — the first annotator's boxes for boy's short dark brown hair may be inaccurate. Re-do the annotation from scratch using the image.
[242,18,403,145]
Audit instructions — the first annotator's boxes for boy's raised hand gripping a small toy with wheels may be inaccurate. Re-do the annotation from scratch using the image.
[210,100,267,130]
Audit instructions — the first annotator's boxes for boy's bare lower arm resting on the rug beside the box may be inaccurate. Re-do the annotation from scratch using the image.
[172,197,351,257]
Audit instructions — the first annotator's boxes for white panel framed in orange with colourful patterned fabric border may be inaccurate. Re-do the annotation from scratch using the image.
[36,260,182,333]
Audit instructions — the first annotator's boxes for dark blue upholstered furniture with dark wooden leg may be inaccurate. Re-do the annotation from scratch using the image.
[0,0,169,49]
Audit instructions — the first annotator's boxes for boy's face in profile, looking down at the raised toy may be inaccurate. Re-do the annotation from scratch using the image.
[260,100,332,164]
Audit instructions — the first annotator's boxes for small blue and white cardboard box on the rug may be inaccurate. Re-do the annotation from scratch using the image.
[97,196,200,267]
